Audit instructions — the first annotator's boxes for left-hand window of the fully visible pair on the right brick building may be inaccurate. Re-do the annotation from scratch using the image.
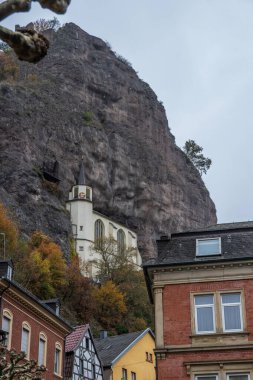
[194,294,215,334]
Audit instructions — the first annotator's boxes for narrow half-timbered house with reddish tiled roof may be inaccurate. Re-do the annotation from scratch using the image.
[64,325,103,380]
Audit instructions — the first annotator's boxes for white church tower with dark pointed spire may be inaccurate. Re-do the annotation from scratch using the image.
[66,160,94,261]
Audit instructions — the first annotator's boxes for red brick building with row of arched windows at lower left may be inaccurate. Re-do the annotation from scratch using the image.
[0,261,72,380]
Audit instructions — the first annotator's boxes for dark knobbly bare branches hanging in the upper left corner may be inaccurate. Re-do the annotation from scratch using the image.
[0,0,71,63]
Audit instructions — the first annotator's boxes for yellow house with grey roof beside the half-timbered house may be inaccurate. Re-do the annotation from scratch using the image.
[95,328,156,380]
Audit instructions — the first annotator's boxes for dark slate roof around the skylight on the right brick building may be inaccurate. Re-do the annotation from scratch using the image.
[143,221,253,268]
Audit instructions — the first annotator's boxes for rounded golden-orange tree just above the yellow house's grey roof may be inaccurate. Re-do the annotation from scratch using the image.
[92,281,127,331]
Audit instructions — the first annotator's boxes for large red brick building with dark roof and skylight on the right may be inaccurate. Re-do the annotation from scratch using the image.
[144,222,253,380]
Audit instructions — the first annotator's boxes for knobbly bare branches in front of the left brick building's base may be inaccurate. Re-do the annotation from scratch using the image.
[0,346,46,380]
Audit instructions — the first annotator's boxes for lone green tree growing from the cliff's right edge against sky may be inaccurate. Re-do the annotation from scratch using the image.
[183,140,212,176]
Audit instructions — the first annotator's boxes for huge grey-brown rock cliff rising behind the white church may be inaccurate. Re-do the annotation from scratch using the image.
[0,24,216,258]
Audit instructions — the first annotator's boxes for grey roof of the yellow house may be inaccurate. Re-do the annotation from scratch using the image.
[95,328,154,367]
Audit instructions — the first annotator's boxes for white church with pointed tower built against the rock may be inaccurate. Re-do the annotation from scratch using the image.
[66,161,141,276]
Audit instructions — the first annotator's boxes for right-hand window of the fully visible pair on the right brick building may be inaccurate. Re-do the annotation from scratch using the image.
[221,293,242,332]
